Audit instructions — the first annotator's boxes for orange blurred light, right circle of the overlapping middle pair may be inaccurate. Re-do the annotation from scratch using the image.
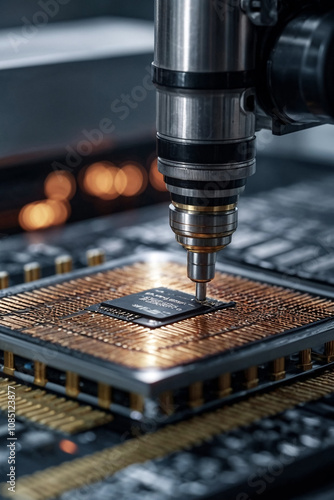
[115,163,147,197]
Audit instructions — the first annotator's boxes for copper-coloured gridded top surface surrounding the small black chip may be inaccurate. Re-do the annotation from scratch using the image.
[0,263,334,368]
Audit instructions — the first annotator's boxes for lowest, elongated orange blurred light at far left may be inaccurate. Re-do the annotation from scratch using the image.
[19,200,71,231]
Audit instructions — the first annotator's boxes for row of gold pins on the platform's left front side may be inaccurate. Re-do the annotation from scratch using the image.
[3,351,144,413]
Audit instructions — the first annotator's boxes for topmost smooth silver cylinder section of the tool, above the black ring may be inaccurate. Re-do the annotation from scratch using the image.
[155,0,254,72]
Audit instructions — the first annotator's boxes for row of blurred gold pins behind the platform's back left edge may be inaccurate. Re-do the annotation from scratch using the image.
[0,248,105,290]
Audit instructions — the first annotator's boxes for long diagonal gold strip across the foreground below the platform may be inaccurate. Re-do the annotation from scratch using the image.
[2,371,334,500]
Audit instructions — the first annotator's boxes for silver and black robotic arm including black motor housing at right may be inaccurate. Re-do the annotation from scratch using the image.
[153,0,334,301]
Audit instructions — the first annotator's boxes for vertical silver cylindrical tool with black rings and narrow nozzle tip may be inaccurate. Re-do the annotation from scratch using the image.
[153,0,255,300]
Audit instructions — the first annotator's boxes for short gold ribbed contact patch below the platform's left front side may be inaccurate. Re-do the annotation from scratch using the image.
[0,378,112,434]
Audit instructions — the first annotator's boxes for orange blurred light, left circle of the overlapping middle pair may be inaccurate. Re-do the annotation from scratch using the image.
[83,162,119,200]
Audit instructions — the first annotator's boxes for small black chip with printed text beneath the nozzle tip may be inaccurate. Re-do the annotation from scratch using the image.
[87,287,235,328]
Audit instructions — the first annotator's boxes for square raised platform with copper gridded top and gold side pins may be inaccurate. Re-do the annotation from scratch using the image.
[0,254,334,419]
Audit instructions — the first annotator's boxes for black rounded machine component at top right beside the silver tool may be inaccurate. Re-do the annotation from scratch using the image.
[257,2,334,135]
